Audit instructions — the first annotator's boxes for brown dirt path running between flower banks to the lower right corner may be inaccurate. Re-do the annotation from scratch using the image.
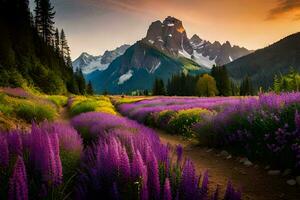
[157,130,300,200]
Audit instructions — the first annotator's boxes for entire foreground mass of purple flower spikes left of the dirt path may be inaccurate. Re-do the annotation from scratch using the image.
[0,95,241,200]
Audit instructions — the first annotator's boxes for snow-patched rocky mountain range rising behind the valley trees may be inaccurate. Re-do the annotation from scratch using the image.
[73,17,251,93]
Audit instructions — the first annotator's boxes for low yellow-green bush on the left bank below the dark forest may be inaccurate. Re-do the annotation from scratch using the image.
[16,102,56,123]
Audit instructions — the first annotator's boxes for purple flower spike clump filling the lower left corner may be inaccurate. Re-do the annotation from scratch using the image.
[0,122,83,200]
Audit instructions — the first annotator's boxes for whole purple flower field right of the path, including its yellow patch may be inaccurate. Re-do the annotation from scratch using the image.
[115,93,300,175]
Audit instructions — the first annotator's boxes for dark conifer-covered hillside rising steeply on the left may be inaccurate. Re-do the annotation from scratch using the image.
[0,0,85,94]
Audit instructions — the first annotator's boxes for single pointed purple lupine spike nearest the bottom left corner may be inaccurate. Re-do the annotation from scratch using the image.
[8,156,28,200]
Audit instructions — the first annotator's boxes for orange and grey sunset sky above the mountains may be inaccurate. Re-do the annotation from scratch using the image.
[32,0,300,59]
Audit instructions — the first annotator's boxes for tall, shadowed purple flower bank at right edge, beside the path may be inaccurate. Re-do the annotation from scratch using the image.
[194,93,300,175]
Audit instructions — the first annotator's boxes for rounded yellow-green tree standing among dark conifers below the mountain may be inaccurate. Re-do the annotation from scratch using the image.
[196,74,218,97]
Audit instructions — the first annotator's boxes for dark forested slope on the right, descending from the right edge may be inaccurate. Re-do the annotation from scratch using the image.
[226,33,300,88]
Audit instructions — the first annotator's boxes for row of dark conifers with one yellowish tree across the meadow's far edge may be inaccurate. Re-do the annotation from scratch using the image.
[152,66,254,96]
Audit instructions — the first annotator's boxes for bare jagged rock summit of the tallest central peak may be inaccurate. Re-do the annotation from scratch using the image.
[143,17,193,56]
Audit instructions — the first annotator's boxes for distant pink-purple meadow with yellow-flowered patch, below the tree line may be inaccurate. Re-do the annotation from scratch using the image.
[115,97,241,137]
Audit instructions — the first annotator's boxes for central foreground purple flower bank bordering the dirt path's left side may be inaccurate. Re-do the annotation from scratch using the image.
[72,112,241,200]
